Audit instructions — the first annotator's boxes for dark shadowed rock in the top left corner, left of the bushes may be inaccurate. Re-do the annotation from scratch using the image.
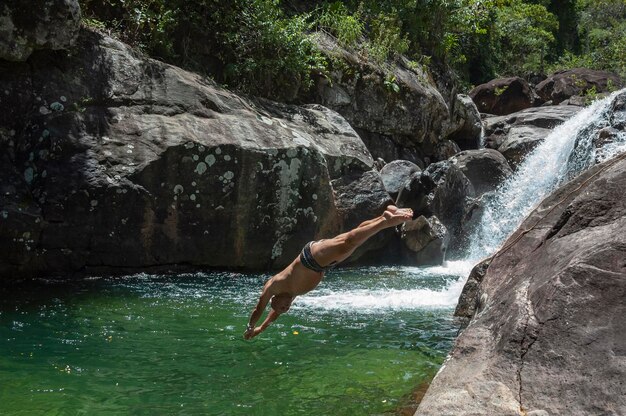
[0,0,80,61]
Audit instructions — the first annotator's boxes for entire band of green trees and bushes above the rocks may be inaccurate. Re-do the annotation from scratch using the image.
[80,0,626,97]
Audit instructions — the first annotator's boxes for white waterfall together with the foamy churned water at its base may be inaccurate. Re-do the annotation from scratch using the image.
[298,89,626,313]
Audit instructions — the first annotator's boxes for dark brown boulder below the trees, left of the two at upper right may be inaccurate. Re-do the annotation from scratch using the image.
[469,77,538,115]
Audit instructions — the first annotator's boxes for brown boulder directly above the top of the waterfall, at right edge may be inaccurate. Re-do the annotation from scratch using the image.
[537,68,623,104]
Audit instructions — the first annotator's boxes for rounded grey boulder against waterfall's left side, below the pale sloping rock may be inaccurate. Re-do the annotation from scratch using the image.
[452,149,513,196]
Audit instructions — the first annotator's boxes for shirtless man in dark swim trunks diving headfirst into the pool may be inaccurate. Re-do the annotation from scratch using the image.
[243,205,413,339]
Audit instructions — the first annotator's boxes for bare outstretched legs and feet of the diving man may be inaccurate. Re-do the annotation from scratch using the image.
[311,205,413,267]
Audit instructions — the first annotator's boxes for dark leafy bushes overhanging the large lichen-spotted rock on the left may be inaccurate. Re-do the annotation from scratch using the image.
[81,0,325,100]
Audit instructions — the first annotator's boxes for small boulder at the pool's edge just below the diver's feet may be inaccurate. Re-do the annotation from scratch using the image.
[401,216,448,266]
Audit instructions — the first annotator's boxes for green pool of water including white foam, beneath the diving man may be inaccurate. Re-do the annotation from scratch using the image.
[0,267,458,415]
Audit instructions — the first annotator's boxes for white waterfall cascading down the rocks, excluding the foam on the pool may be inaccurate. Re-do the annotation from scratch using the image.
[465,89,626,263]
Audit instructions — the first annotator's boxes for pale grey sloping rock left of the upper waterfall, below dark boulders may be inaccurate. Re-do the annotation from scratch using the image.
[485,105,580,168]
